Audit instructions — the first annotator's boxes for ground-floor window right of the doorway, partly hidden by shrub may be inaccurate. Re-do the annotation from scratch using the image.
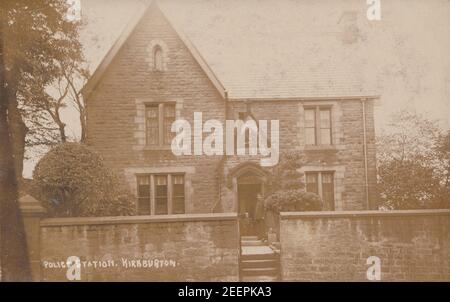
[305,172,335,211]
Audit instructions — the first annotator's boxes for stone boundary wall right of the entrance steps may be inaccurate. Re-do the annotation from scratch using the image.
[280,210,450,281]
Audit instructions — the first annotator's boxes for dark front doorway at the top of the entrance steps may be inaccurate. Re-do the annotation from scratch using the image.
[238,184,262,236]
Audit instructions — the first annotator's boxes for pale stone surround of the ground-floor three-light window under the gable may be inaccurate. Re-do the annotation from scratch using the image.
[124,166,195,216]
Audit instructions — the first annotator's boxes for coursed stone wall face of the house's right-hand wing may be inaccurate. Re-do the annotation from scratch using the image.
[222,100,377,210]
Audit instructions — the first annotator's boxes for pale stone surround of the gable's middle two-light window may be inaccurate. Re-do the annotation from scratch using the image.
[133,98,183,151]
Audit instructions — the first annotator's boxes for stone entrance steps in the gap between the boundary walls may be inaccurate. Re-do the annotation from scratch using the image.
[240,236,280,281]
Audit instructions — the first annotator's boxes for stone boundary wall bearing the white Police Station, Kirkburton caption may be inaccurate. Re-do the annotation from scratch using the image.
[40,214,239,281]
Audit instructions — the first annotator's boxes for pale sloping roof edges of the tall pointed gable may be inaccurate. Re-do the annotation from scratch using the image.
[82,1,227,98]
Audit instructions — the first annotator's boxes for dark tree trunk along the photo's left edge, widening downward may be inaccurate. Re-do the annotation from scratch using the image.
[0,14,31,281]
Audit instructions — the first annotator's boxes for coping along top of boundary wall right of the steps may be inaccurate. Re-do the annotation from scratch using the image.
[280,209,450,220]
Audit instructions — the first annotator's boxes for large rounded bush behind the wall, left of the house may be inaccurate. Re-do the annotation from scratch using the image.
[33,143,134,217]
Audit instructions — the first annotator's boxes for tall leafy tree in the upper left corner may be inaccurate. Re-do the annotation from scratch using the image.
[0,0,82,177]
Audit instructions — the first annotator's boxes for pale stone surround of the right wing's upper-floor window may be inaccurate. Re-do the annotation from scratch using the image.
[297,100,345,150]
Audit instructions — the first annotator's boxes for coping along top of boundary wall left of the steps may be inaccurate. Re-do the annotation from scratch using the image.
[41,213,237,227]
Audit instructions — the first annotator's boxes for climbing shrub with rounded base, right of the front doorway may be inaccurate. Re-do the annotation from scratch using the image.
[264,152,322,213]
